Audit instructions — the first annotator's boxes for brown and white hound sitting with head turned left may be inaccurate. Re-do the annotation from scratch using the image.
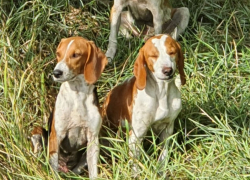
[49,37,108,179]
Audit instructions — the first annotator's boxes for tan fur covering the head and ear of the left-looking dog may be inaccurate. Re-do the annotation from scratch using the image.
[56,37,108,84]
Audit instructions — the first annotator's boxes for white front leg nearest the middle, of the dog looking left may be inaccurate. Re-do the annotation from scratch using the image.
[87,132,100,180]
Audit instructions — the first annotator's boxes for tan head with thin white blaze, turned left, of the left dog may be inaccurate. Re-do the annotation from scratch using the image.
[53,37,108,84]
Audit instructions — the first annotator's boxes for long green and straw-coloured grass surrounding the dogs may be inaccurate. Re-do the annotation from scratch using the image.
[0,0,250,180]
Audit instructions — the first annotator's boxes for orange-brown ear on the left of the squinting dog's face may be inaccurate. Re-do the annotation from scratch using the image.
[134,49,147,90]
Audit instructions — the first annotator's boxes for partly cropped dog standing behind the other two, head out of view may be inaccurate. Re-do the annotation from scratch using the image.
[106,0,189,62]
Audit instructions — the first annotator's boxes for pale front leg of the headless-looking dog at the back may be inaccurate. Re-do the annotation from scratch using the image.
[105,1,123,62]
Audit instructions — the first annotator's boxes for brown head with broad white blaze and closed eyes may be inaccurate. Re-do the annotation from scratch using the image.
[134,35,186,90]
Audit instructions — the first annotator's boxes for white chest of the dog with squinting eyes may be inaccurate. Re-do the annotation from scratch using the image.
[132,79,182,129]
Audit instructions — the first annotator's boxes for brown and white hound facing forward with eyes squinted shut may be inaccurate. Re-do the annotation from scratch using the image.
[102,35,186,174]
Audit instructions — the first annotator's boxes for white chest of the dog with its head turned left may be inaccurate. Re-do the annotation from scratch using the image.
[55,79,101,136]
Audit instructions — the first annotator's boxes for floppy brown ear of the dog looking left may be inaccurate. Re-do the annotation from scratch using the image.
[84,41,108,84]
